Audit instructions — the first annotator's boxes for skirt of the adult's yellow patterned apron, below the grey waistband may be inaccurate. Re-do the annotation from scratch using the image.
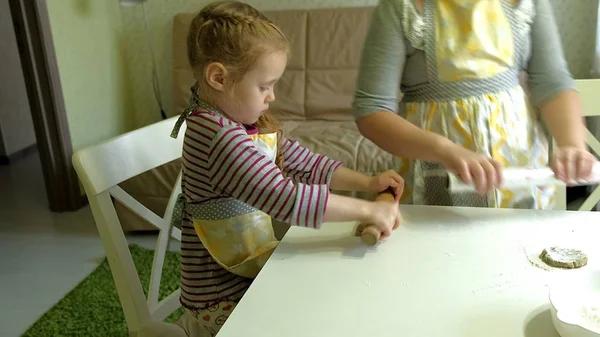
[399,86,556,209]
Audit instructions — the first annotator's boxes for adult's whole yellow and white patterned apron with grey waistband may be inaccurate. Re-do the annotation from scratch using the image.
[399,0,555,209]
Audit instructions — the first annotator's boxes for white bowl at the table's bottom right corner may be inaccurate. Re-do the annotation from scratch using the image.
[549,270,600,337]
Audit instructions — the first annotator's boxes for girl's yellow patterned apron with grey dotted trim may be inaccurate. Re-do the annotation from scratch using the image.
[173,133,279,278]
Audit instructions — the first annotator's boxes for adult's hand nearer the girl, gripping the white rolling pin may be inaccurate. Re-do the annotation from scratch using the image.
[441,143,502,194]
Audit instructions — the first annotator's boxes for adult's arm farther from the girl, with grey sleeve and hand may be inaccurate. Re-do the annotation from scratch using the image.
[527,0,595,182]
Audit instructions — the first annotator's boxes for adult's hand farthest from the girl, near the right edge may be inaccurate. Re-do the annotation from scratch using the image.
[552,146,596,184]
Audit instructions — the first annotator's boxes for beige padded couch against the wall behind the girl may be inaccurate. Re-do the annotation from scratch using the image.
[116,7,394,230]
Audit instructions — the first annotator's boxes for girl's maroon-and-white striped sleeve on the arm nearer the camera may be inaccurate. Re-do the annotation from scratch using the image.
[209,126,329,228]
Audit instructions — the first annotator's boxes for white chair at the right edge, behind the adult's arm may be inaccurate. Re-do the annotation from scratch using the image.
[556,80,600,211]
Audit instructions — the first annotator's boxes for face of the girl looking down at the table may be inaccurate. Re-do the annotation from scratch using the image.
[218,51,287,125]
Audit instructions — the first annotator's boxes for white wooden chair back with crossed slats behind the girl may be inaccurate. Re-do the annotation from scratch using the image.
[73,118,185,332]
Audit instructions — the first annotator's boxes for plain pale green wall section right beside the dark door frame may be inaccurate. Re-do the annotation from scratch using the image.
[47,0,133,150]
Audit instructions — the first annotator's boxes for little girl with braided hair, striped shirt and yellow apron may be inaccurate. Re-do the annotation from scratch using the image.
[172,1,403,336]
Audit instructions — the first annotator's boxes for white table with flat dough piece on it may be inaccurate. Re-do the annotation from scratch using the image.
[218,206,600,337]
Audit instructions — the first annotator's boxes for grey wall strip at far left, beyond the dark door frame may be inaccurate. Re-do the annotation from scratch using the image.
[0,0,36,156]
